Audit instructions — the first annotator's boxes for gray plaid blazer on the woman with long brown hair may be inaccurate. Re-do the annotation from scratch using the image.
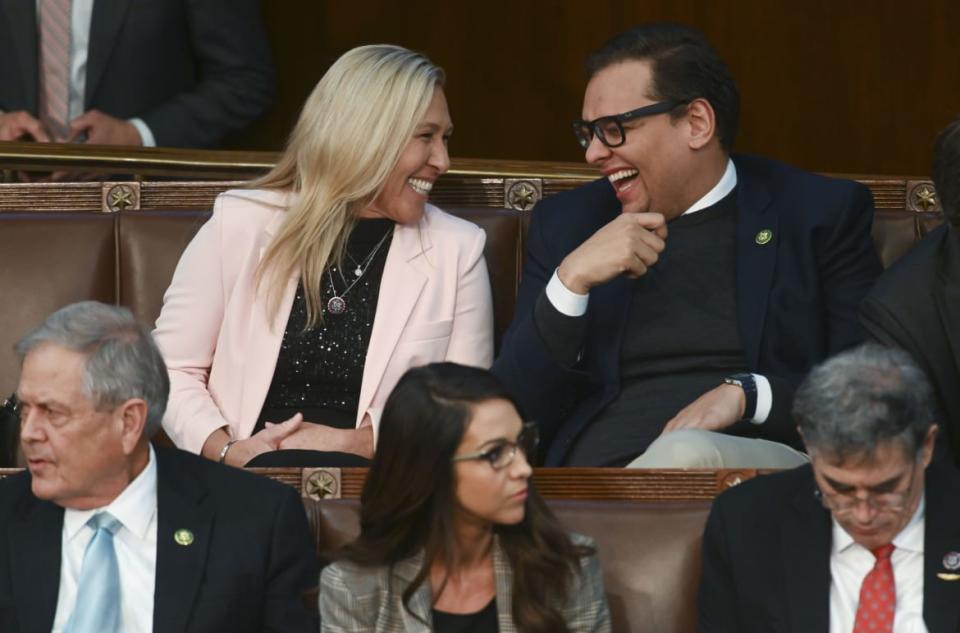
[320,535,610,633]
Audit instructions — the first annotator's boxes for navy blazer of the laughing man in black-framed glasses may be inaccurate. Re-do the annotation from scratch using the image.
[493,156,882,465]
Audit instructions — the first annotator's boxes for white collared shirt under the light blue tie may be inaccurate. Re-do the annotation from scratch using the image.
[52,446,157,633]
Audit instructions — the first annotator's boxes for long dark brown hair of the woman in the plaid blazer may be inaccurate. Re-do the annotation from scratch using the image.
[333,363,593,633]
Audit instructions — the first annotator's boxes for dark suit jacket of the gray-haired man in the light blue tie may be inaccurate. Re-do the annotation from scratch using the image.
[0,449,319,633]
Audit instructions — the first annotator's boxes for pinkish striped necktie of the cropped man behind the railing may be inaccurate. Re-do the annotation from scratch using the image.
[39,0,72,141]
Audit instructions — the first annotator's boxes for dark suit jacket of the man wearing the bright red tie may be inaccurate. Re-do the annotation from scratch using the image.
[698,465,960,633]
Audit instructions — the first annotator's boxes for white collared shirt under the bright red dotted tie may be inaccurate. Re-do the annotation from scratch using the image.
[830,497,927,633]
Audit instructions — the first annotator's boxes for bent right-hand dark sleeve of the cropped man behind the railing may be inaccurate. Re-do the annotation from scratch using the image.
[138,0,276,147]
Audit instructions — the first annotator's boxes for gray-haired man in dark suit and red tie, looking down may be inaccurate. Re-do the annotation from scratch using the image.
[698,344,960,633]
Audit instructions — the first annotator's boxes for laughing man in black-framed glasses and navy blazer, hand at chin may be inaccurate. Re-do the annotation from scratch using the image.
[494,24,881,468]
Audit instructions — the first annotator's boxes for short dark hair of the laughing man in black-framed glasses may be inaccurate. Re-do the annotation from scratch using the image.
[586,23,740,152]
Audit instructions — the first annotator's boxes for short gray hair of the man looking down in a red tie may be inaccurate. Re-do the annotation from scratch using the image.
[793,343,935,461]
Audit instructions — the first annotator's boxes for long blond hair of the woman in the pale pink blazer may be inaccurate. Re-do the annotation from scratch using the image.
[250,44,444,328]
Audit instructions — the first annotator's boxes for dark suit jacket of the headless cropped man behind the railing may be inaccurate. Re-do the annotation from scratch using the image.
[0,0,275,147]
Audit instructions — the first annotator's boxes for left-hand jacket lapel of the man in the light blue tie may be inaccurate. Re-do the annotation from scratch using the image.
[5,500,63,633]
